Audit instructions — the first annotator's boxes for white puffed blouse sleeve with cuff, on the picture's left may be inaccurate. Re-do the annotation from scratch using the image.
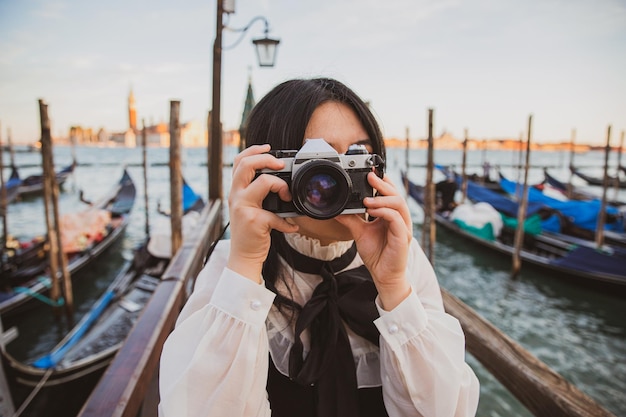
[159,241,274,417]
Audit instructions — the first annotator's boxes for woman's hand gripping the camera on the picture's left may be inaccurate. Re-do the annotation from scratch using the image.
[226,145,298,283]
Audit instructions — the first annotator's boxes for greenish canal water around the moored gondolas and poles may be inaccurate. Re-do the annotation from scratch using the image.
[3,147,626,417]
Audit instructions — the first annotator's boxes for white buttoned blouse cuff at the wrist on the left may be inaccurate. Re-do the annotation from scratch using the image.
[210,268,276,326]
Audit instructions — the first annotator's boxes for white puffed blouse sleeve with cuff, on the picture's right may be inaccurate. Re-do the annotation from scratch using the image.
[375,239,479,417]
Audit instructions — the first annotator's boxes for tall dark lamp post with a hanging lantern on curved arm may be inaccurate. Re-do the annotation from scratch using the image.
[207,0,280,200]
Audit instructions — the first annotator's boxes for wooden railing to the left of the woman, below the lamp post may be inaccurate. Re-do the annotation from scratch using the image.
[79,201,222,417]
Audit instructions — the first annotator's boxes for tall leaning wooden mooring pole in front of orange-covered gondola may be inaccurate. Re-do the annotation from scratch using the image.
[39,99,74,316]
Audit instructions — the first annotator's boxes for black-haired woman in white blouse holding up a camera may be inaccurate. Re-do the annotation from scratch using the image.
[159,79,479,417]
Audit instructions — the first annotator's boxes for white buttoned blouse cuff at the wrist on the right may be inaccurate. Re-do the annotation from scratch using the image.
[374,291,428,351]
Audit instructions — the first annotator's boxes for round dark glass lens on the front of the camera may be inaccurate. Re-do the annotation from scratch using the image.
[291,159,352,220]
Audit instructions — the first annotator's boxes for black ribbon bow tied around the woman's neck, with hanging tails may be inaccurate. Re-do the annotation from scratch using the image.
[276,234,380,417]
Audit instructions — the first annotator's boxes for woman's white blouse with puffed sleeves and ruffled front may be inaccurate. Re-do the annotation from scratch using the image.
[159,234,479,417]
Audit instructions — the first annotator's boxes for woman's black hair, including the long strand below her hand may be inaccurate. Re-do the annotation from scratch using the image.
[245,78,385,309]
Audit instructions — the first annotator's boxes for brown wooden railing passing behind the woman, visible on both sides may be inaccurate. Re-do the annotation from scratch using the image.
[79,197,613,417]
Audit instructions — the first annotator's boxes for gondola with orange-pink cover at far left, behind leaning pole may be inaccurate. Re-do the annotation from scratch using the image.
[0,169,136,317]
